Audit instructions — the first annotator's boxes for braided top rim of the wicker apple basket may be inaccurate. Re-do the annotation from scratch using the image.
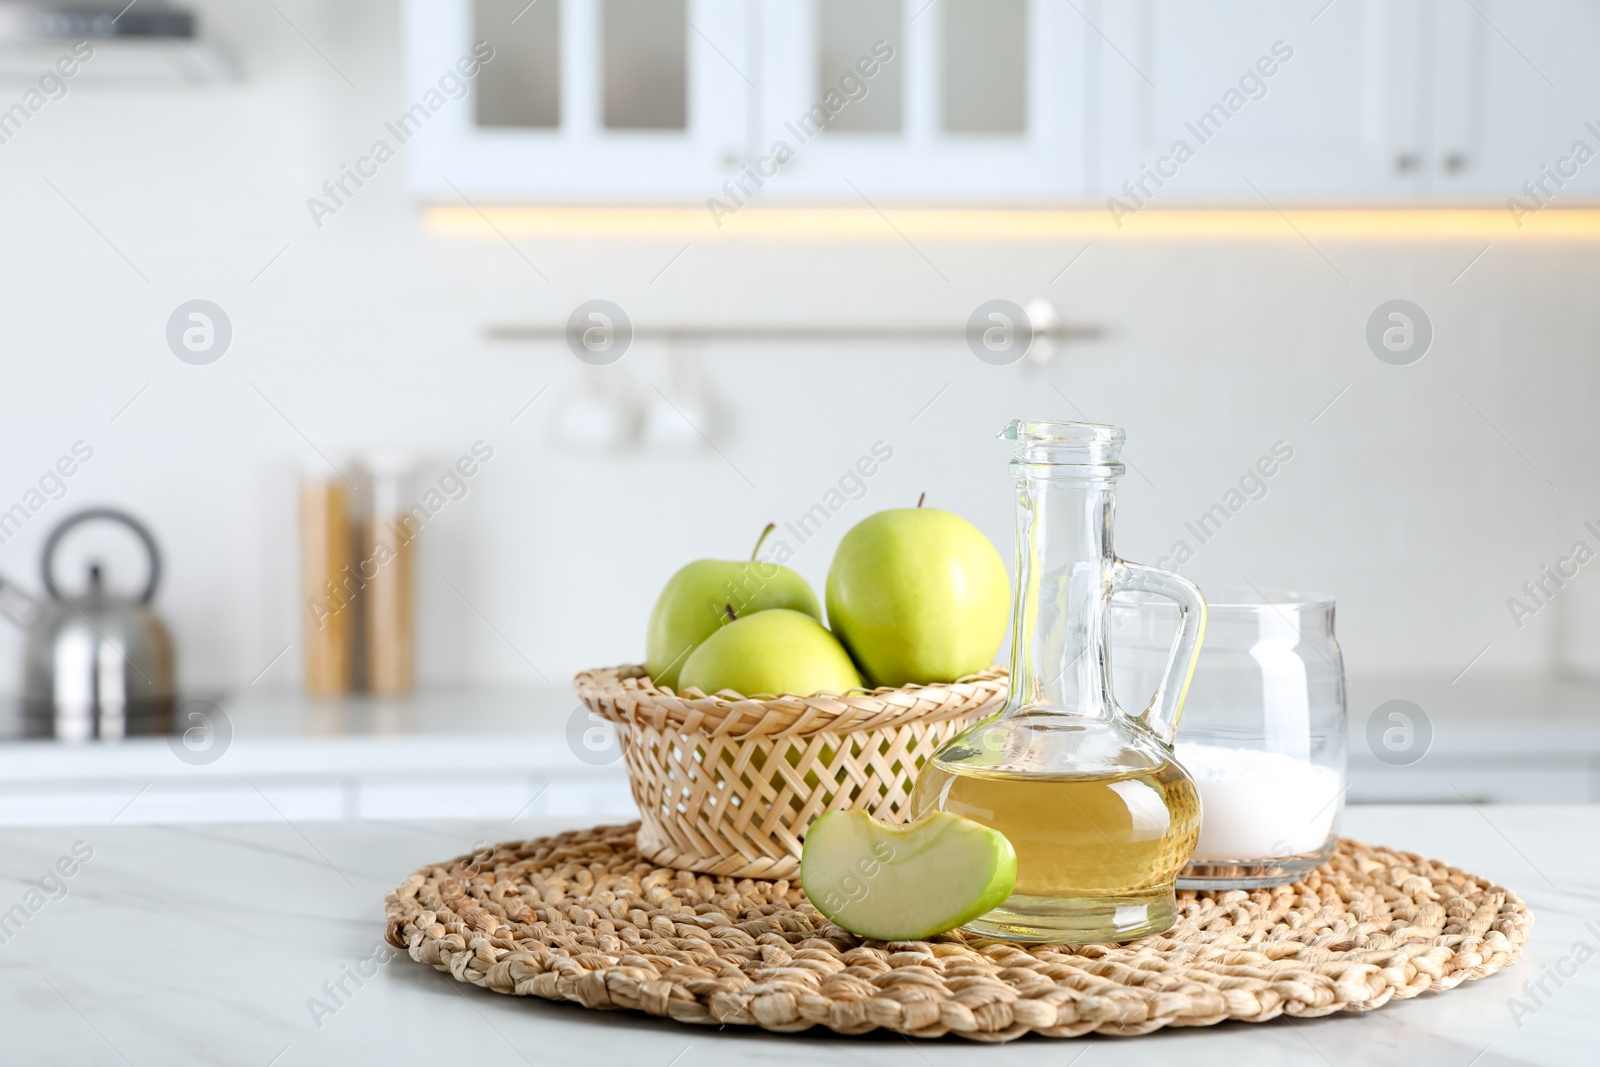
[573,664,1010,737]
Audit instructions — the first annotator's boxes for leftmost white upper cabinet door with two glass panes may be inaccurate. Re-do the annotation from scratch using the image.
[400,0,755,203]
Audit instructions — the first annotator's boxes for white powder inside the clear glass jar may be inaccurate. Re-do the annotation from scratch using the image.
[1178,741,1341,862]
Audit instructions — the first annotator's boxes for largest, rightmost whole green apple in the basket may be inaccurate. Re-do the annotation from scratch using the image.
[827,507,1011,686]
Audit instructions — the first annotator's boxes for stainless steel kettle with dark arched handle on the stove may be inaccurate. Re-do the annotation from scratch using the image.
[0,507,174,741]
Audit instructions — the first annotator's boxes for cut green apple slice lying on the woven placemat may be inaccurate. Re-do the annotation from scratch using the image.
[800,811,1016,941]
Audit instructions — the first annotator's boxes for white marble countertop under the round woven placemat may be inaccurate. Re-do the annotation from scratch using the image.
[0,805,1600,1067]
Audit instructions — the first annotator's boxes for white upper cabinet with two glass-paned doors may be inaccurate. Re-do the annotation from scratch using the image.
[405,0,1094,203]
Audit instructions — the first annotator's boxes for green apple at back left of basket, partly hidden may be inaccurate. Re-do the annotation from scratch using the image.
[645,523,822,689]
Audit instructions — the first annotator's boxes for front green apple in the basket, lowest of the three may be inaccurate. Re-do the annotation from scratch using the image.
[678,608,861,696]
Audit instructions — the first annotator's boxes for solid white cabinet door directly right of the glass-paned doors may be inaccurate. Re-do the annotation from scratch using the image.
[1085,0,1432,210]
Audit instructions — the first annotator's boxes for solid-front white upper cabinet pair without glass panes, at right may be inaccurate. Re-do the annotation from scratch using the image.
[1099,0,1600,210]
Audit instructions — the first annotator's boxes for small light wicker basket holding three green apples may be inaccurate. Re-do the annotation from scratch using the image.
[573,667,1006,878]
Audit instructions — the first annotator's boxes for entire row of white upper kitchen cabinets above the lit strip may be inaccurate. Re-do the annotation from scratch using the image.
[405,0,1600,206]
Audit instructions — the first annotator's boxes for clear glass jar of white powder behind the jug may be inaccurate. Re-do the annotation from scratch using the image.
[1112,589,1346,889]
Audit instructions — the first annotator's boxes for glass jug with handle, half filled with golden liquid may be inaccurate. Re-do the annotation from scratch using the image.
[914,421,1206,944]
